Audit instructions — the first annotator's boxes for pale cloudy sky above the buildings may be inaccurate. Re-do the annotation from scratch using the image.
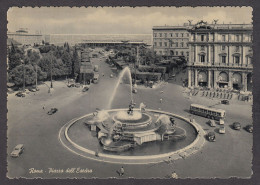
[7,7,252,34]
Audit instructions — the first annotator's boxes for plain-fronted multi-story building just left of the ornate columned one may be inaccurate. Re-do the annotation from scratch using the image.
[153,24,190,59]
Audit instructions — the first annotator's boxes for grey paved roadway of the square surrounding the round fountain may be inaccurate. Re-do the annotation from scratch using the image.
[7,54,252,178]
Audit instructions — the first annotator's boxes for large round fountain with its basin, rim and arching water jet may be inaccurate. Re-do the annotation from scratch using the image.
[60,67,203,162]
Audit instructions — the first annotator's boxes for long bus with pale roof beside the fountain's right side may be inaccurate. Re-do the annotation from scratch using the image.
[190,104,226,121]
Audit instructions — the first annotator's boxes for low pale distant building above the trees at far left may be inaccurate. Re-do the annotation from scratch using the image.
[7,29,45,45]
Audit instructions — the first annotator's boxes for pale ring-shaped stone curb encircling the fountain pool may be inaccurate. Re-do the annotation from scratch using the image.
[59,109,205,164]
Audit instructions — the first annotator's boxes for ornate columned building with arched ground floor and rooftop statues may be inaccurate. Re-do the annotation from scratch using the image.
[188,21,253,91]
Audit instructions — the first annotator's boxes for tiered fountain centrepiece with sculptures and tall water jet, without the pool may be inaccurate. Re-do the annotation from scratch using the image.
[86,67,186,152]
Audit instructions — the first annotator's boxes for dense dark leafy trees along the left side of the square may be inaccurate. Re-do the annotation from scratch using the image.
[8,43,80,86]
